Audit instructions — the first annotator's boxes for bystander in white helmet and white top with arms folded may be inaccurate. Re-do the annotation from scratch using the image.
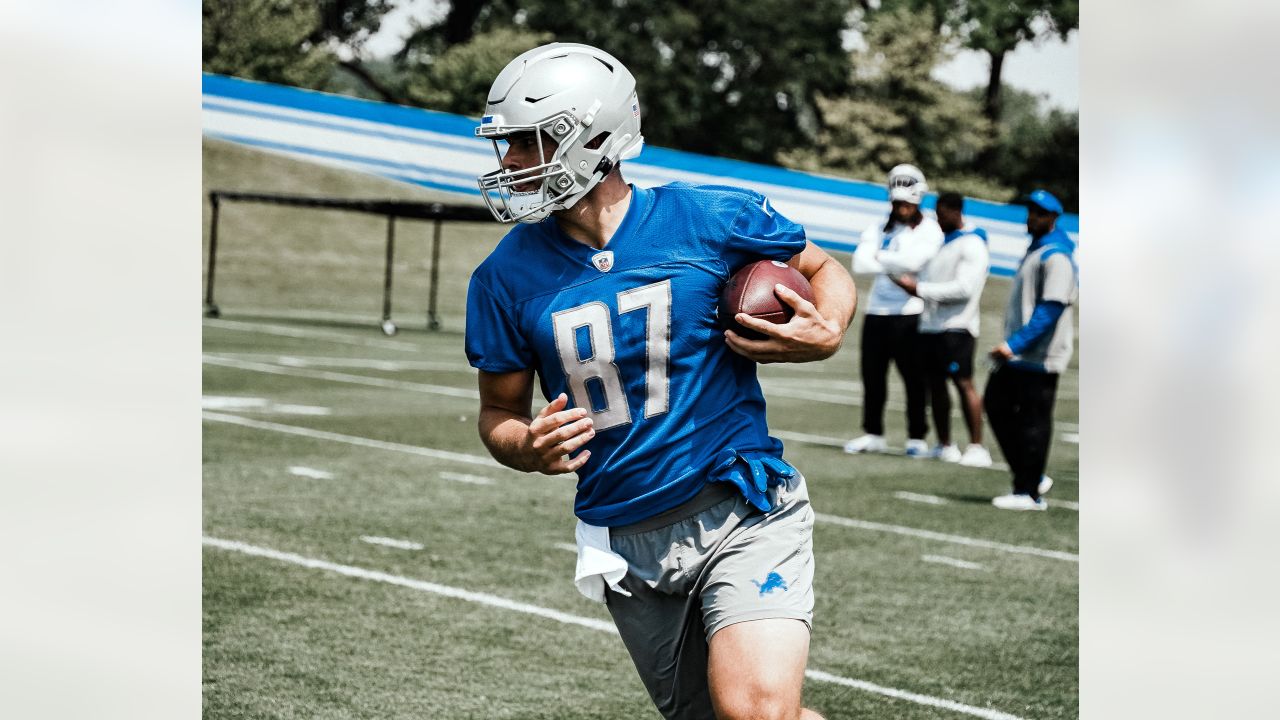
[845,164,942,457]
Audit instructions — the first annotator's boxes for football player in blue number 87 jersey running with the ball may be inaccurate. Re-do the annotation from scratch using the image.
[466,44,855,719]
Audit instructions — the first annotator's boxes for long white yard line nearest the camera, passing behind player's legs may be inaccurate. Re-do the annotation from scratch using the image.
[204,537,1021,720]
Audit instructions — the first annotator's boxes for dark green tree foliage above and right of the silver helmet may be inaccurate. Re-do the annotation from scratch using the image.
[481,0,854,163]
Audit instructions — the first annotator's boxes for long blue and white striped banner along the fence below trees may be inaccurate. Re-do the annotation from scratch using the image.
[202,73,1080,275]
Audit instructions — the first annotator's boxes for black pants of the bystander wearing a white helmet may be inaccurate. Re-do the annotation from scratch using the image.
[861,315,929,439]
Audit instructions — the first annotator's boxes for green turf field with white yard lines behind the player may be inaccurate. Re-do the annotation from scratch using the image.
[204,141,1079,720]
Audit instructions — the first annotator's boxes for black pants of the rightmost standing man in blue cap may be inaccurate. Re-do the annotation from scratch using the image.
[983,365,1057,497]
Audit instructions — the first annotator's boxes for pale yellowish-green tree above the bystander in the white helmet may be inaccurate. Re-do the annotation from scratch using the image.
[780,8,1009,197]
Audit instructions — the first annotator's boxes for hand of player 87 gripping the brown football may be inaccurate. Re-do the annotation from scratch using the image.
[724,284,845,363]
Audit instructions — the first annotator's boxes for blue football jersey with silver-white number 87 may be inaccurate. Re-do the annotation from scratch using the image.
[466,183,805,527]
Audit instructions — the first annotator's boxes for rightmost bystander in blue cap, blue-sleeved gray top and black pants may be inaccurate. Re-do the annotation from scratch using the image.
[983,190,1079,510]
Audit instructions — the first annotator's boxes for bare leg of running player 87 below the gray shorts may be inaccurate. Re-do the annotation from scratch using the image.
[707,619,822,720]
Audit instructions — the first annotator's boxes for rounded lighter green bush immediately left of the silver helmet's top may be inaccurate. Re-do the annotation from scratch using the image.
[404,27,552,115]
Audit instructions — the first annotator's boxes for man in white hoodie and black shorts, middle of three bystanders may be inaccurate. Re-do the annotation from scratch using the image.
[895,192,991,468]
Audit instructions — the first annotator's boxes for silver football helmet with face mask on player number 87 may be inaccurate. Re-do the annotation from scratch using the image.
[476,42,644,223]
